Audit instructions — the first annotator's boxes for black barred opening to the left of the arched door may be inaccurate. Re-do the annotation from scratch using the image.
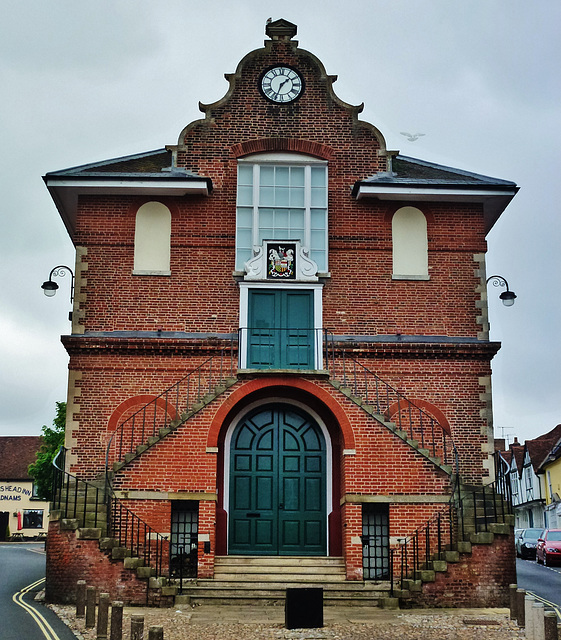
[169,500,199,580]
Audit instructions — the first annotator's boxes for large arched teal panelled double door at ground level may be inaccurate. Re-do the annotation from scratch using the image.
[229,404,327,555]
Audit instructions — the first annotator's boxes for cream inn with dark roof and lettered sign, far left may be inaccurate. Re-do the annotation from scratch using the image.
[0,436,49,541]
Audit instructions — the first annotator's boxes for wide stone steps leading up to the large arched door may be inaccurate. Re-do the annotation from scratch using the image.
[176,556,389,606]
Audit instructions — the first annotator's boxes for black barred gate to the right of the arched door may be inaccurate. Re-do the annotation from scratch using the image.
[362,504,390,580]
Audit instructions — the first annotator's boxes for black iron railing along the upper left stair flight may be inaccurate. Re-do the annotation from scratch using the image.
[105,348,235,470]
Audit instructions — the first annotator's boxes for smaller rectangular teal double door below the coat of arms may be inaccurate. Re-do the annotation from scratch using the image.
[247,289,315,369]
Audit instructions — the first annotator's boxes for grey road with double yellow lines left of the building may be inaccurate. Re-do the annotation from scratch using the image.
[0,542,76,640]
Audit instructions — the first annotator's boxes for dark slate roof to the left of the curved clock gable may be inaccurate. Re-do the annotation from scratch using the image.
[45,149,206,180]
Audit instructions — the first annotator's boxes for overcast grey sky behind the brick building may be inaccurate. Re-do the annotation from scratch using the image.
[0,0,561,448]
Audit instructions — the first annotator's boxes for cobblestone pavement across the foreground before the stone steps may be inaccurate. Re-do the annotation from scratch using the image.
[49,605,525,640]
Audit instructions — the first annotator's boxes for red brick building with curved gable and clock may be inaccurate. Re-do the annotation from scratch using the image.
[45,20,517,608]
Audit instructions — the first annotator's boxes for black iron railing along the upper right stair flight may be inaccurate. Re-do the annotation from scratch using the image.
[330,345,459,474]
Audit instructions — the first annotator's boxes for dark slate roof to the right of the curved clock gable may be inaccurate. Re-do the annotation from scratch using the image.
[361,155,516,189]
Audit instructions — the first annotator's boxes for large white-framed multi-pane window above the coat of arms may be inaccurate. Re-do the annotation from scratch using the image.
[236,154,327,272]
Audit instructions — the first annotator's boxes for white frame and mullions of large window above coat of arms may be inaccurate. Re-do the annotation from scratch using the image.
[236,153,329,274]
